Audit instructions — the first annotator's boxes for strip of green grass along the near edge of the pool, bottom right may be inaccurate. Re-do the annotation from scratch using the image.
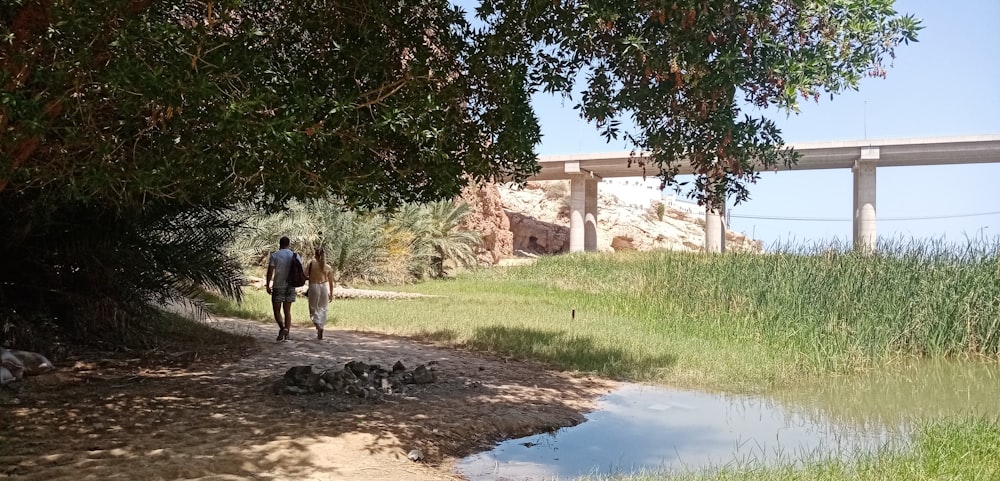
[578,419,1000,481]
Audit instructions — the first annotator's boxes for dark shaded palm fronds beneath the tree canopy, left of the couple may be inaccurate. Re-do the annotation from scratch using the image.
[0,202,243,348]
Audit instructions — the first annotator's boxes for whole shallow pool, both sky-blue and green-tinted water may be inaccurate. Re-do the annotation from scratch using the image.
[456,363,1000,481]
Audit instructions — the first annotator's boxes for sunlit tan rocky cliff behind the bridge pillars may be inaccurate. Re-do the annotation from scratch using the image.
[461,181,761,264]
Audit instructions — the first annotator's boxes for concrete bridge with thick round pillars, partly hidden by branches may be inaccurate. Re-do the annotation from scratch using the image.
[528,134,1000,252]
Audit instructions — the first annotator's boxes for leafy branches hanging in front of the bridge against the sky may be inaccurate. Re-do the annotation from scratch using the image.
[478,0,921,206]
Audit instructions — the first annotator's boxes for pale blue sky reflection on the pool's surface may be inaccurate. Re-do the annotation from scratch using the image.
[458,385,889,480]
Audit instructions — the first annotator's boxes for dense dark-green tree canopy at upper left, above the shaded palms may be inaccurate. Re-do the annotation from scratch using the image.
[0,0,538,206]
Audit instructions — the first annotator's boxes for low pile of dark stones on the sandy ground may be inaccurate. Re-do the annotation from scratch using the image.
[274,361,437,401]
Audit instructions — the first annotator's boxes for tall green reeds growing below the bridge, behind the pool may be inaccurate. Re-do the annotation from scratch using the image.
[518,240,1000,370]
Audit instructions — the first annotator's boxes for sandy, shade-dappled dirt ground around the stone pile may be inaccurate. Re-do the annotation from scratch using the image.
[0,319,616,481]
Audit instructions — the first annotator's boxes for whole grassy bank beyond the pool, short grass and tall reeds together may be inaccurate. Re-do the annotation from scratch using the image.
[207,236,1000,391]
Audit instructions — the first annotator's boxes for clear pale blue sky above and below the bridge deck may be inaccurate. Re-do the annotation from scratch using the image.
[516,0,1000,245]
